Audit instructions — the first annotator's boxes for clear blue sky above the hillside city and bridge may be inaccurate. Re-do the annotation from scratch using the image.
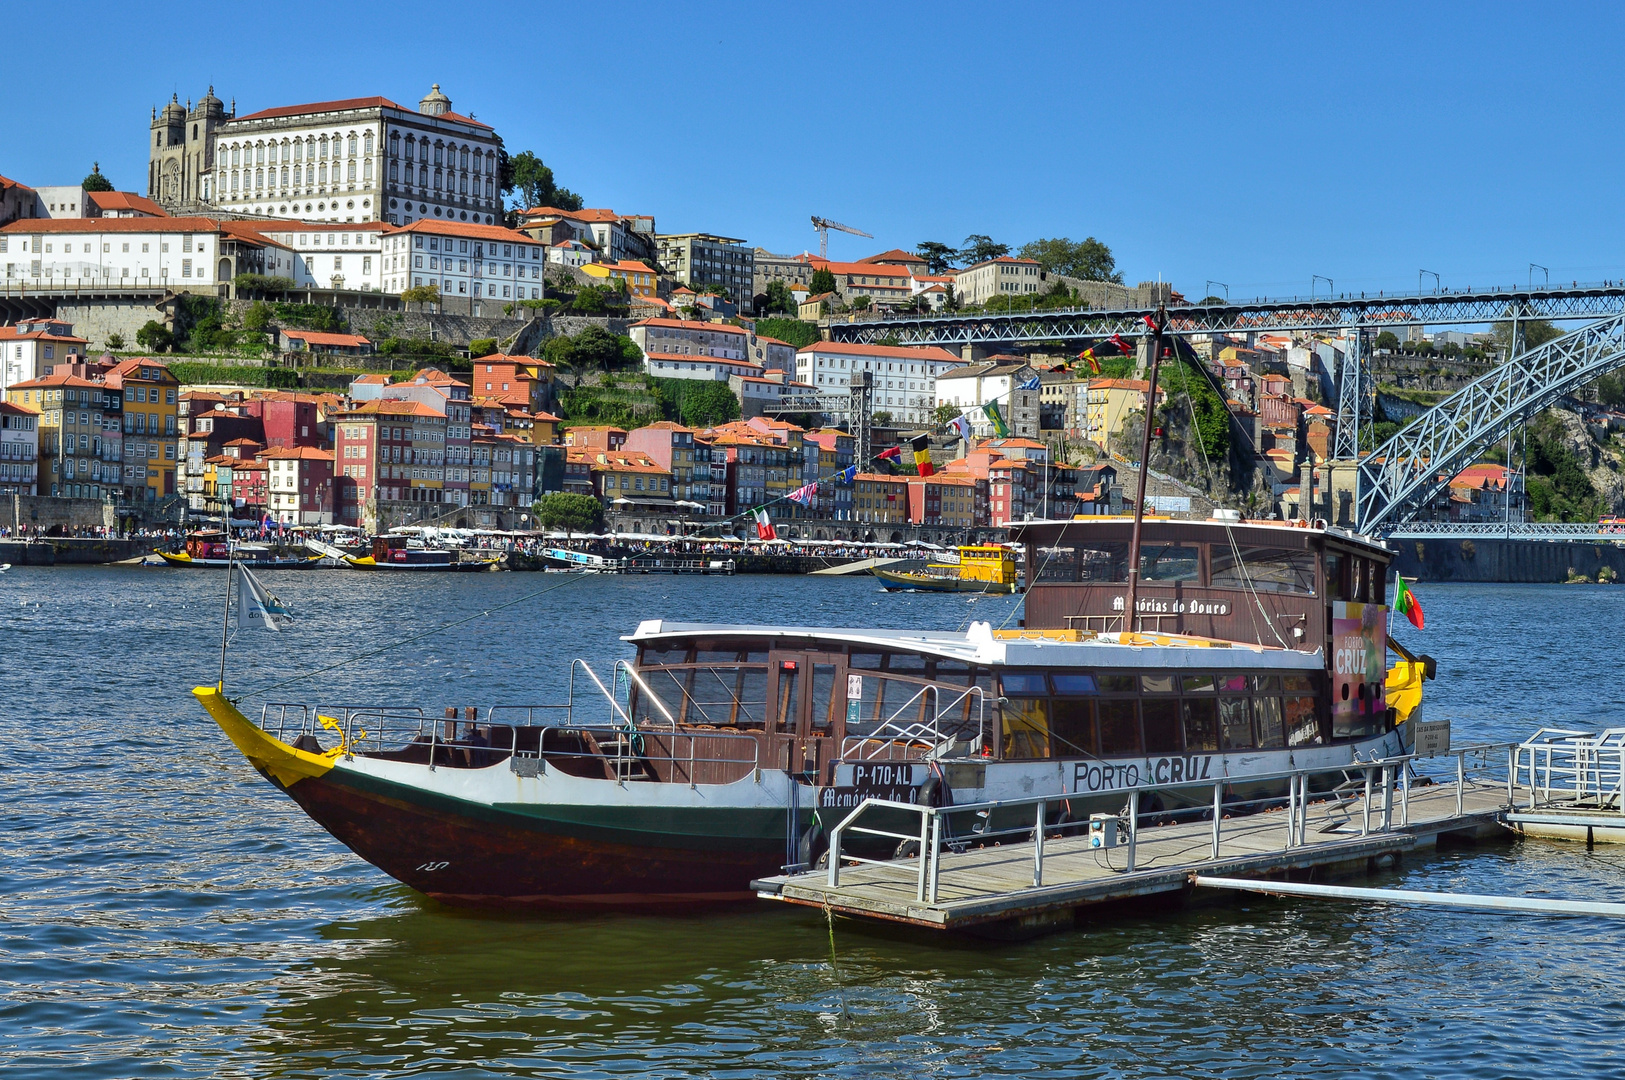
[0,2,1625,299]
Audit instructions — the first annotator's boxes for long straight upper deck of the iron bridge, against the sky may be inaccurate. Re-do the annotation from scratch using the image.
[829,281,1625,346]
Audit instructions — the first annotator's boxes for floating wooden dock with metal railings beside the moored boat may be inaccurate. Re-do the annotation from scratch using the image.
[754,745,1519,932]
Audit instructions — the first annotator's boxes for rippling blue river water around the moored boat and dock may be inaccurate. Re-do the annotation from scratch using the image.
[0,567,1625,1080]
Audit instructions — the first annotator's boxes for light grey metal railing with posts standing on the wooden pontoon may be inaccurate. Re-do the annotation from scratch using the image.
[829,744,1516,905]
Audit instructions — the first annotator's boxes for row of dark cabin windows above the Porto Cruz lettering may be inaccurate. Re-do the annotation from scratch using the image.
[999,671,1328,758]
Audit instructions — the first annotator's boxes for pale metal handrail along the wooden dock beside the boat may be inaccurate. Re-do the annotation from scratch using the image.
[829,742,1516,905]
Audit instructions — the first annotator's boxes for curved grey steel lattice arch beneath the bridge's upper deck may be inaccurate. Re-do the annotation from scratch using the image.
[1355,313,1625,533]
